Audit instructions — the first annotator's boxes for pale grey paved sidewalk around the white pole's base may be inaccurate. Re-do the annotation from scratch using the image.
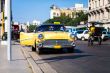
[0,41,33,73]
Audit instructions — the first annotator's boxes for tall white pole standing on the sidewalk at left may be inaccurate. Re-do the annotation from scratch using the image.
[5,0,12,61]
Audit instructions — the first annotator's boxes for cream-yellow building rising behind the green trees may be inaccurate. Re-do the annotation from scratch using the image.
[50,4,88,19]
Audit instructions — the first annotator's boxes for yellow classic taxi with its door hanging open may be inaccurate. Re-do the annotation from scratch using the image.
[20,24,75,54]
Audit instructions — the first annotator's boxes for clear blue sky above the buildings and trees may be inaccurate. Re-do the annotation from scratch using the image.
[12,0,88,23]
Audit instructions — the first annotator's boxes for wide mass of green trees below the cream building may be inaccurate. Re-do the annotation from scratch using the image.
[44,11,88,26]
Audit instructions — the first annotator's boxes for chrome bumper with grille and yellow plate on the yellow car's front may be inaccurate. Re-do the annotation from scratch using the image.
[37,40,76,49]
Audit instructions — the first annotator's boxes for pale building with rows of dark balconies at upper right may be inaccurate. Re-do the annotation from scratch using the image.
[88,0,110,28]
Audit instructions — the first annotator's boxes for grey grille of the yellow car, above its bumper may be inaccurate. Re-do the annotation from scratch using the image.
[43,39,71,46]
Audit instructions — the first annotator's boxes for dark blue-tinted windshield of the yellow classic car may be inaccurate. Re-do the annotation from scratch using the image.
[36,25,65,31]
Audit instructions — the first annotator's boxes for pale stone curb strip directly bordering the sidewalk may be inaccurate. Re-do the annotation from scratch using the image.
[21,47,43,73]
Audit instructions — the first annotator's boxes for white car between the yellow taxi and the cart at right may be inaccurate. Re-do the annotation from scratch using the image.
[76,30,89,40]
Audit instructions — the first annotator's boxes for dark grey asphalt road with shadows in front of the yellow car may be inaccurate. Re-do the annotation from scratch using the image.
[22,41,110,73]
